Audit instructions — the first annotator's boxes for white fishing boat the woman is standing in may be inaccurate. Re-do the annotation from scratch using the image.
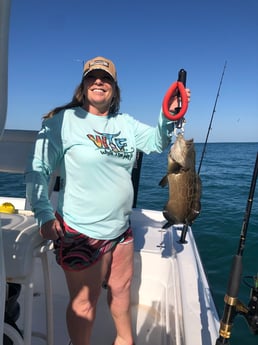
[0,0,219,345]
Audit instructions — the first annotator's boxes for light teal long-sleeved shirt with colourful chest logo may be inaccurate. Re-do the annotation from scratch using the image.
[26,107,174,239]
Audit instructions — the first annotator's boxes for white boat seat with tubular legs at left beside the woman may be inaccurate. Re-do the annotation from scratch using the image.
[0,211,54,345]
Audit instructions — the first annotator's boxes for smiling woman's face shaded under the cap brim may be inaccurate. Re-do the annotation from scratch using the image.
[83,70,115,116]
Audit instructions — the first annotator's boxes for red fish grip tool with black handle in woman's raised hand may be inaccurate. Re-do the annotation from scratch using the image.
[162,69,188,123]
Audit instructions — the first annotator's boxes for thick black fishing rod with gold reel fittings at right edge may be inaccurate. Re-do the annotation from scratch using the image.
[216,152,258,345]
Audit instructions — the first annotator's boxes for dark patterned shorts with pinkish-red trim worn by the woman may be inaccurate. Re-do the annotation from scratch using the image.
[54,214,133,271]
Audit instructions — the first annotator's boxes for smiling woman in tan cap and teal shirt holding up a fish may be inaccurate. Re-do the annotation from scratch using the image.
[26,57,190,345]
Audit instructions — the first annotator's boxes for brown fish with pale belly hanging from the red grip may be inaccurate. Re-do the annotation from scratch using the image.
[159,133,202,228]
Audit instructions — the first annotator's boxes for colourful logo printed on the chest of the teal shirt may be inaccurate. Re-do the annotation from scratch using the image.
[87,130,134,160]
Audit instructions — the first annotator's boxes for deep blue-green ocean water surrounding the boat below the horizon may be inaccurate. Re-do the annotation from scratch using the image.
[0,143,258,345]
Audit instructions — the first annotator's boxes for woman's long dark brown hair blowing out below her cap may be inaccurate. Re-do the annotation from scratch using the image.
[43,79,121,119]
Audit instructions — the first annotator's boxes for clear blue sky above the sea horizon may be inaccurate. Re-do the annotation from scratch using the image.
[6,0,258,142]
